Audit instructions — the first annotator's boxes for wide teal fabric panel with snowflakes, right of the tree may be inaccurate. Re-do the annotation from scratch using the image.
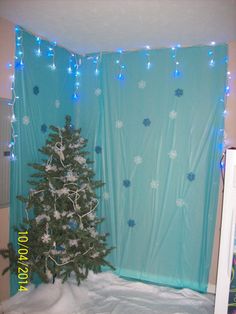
[78,45,227,292]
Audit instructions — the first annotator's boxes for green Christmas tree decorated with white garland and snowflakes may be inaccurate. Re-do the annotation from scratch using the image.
[2,116,113,284]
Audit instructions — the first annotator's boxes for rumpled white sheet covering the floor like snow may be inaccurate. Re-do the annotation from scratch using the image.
[0,272,214,314]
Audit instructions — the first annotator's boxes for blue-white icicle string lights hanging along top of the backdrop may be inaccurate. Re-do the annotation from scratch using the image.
[8,26,231,161]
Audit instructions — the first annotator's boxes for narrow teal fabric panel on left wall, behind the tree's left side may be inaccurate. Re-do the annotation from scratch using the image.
[10,31,74,294]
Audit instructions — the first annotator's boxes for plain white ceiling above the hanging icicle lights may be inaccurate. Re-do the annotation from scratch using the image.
[0,0,236,54]
